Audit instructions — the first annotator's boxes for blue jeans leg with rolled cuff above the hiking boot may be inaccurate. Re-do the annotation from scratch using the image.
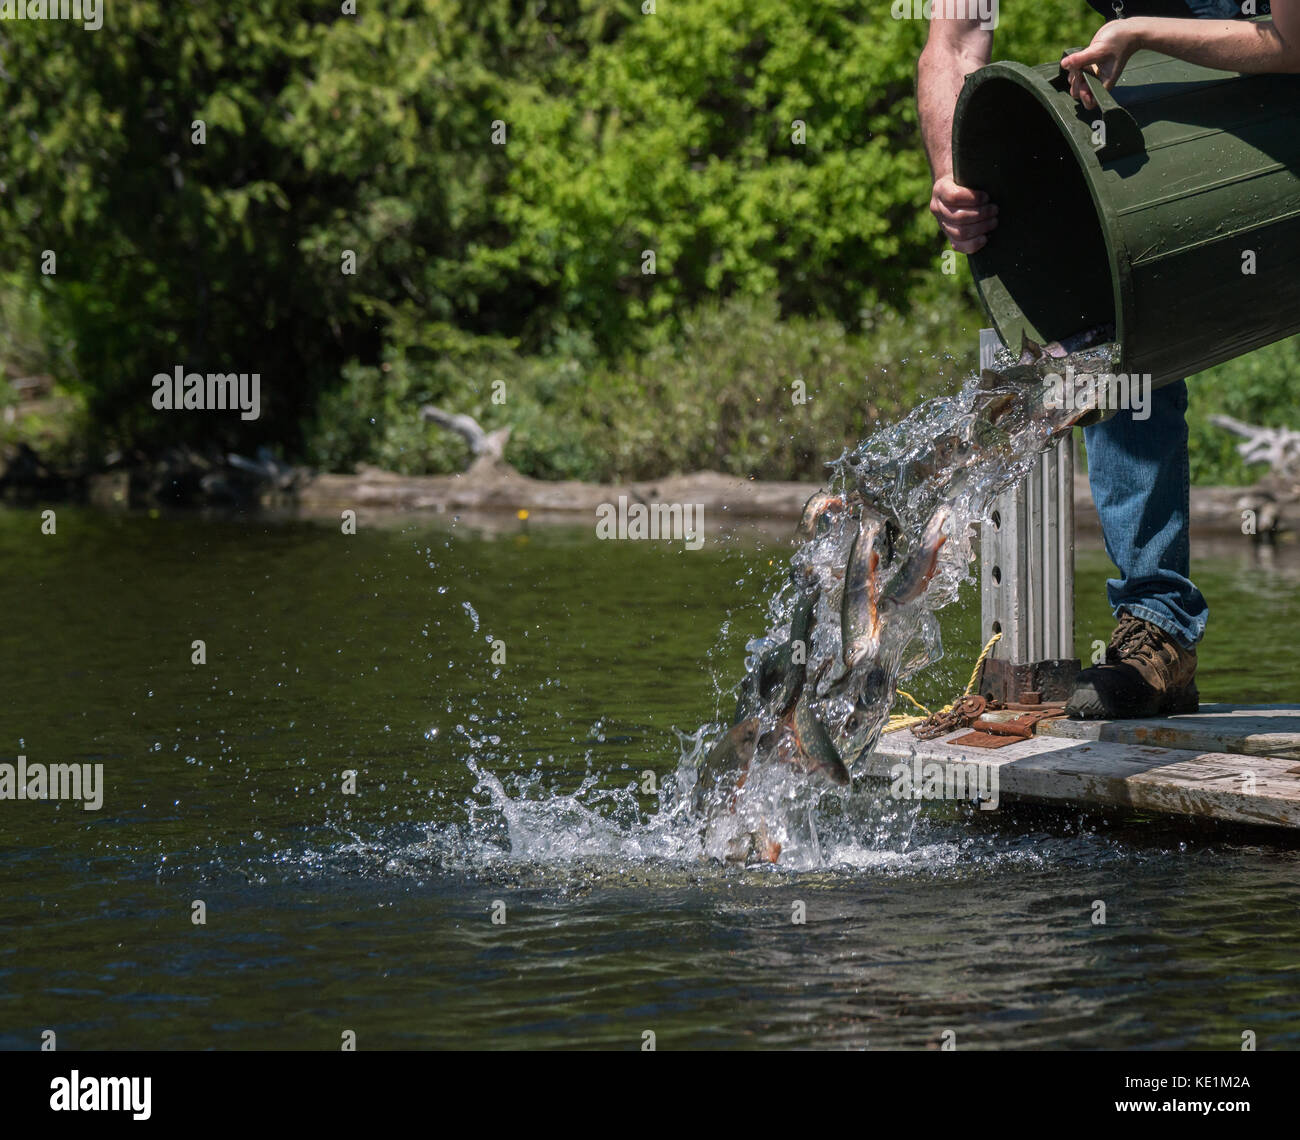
[1083,380,1209,649]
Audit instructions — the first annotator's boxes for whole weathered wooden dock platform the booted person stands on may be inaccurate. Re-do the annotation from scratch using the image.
[867,705,1300,828]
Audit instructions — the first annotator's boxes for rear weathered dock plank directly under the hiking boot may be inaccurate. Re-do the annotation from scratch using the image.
[1039,705,1300,760]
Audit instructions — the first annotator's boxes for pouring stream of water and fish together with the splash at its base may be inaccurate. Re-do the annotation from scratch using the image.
[471,329,1118,870]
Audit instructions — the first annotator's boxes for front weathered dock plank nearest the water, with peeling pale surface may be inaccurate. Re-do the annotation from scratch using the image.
[865,732,1300,828]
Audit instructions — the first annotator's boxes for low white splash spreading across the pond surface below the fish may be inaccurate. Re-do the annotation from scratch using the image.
[253,753,1076,889]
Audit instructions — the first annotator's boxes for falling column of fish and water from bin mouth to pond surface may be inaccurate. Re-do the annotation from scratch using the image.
[694,329,1117,862]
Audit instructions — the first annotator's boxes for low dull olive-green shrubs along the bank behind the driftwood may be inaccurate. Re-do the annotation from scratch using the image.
[315,288,975,481]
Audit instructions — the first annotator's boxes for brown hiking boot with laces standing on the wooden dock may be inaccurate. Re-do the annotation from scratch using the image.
[1065,611,1199,720]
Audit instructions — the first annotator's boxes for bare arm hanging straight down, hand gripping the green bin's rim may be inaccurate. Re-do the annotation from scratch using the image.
[917,16,997,253]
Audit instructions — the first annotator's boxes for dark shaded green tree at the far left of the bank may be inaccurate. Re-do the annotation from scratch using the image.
[0,0,361,450]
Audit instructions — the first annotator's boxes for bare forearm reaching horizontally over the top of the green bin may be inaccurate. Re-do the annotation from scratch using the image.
[1061,0,1300,107]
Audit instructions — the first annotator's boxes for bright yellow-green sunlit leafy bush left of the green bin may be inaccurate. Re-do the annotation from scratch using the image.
[488,0,936,351]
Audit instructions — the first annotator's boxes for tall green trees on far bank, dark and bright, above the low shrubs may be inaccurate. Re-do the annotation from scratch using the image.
[0,0,1112,469]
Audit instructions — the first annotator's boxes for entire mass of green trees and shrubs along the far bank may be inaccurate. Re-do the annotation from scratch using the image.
[0,0,1279,488]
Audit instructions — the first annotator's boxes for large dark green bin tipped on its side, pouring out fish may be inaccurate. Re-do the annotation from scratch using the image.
[953,51,1300,387]
